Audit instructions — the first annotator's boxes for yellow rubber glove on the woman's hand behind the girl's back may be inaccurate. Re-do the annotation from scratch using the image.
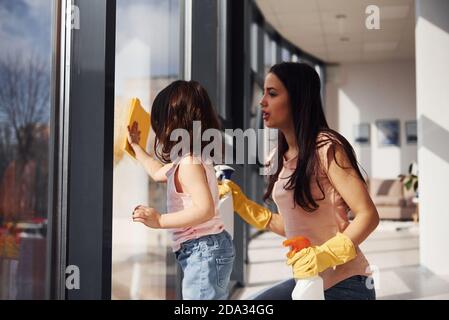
[218,180,272,229]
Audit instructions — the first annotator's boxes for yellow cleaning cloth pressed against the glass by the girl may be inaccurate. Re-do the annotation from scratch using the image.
[125,98,151,159]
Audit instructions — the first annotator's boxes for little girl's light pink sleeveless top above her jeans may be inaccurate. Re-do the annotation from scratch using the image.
[166,155,224,252]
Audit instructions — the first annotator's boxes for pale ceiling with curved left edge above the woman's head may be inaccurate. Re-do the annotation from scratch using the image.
[256,0,415,63]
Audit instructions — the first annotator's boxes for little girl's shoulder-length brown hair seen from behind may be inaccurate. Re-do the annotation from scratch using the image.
[151,80,221,163]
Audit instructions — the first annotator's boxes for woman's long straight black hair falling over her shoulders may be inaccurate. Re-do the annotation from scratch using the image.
[263,62,365,212]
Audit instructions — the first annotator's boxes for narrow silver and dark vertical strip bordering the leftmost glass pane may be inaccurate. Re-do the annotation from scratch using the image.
[45,0,77,300]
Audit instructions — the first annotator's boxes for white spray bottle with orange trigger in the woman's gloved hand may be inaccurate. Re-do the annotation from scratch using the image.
[282,236,324,300]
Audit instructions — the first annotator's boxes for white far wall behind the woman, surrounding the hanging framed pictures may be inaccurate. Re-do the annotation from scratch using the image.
[325,61,417,178]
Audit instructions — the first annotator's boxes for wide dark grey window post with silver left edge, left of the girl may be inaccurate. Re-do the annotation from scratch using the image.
[52,0,116,300]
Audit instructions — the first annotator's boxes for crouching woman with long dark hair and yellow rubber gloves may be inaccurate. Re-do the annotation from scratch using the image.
[221,62,379,300]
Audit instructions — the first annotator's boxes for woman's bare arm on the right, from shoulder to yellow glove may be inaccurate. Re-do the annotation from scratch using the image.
[328,145,379,246]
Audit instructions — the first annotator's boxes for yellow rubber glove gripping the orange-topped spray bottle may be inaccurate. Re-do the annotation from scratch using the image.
[287,232,356,279]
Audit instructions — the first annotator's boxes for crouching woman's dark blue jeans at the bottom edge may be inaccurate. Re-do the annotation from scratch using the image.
[254,276,376,300]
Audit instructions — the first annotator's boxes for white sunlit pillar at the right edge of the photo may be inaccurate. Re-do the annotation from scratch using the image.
[416,0,449,275]
